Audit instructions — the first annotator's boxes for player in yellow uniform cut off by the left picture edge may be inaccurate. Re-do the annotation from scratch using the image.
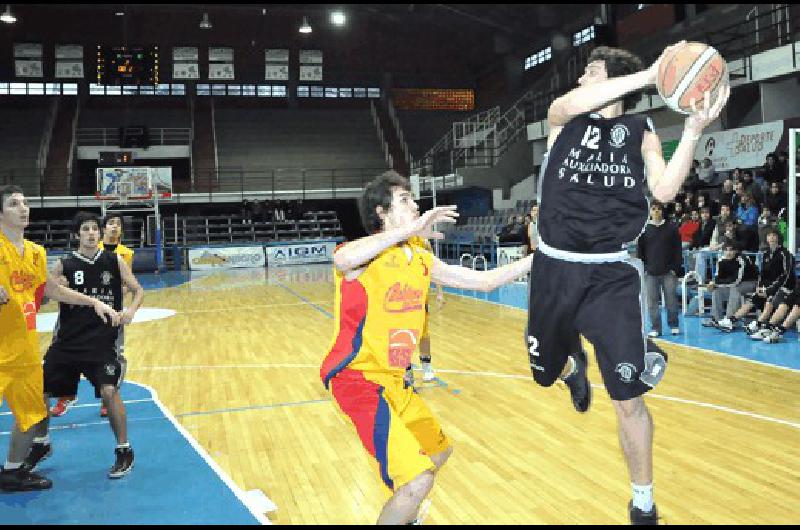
[0,186,120,491]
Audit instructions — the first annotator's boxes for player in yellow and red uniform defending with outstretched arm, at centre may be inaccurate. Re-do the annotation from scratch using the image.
[320,171,532,524]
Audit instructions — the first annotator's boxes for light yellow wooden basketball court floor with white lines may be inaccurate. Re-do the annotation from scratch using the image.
[42,265,800,525]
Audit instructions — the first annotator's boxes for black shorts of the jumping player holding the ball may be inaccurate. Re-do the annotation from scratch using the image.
[526,249,666,401]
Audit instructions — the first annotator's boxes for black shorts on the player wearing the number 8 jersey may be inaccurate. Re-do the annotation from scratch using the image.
[44,349,127,398]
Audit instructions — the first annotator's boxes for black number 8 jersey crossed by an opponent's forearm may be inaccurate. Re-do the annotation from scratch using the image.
[48,250,123,361]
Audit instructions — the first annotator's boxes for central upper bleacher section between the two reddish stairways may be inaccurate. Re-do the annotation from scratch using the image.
[215,107,388,191]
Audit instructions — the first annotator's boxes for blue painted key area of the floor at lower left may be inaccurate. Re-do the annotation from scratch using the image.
[0,381,268,525]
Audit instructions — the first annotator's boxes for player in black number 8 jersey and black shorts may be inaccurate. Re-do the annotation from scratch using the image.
[25,212,144,478]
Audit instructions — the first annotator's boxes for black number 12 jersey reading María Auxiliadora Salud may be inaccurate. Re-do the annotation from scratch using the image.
[538,113,652,254]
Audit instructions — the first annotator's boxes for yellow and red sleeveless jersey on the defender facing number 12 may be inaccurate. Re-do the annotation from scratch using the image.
[320,240,433,387]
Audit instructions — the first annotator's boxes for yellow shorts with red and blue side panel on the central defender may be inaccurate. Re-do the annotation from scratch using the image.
[330,369,450,491]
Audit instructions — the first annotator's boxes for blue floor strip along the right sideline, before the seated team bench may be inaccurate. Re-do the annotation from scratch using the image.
[445,282,800,370]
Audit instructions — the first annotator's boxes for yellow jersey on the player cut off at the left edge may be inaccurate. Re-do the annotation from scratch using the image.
[0,232,47,369]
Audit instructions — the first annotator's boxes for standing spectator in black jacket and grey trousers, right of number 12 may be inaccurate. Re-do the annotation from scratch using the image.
[638,201,682,337]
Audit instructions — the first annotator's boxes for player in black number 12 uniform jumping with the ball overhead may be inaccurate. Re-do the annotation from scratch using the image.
[527,43,730,524]
